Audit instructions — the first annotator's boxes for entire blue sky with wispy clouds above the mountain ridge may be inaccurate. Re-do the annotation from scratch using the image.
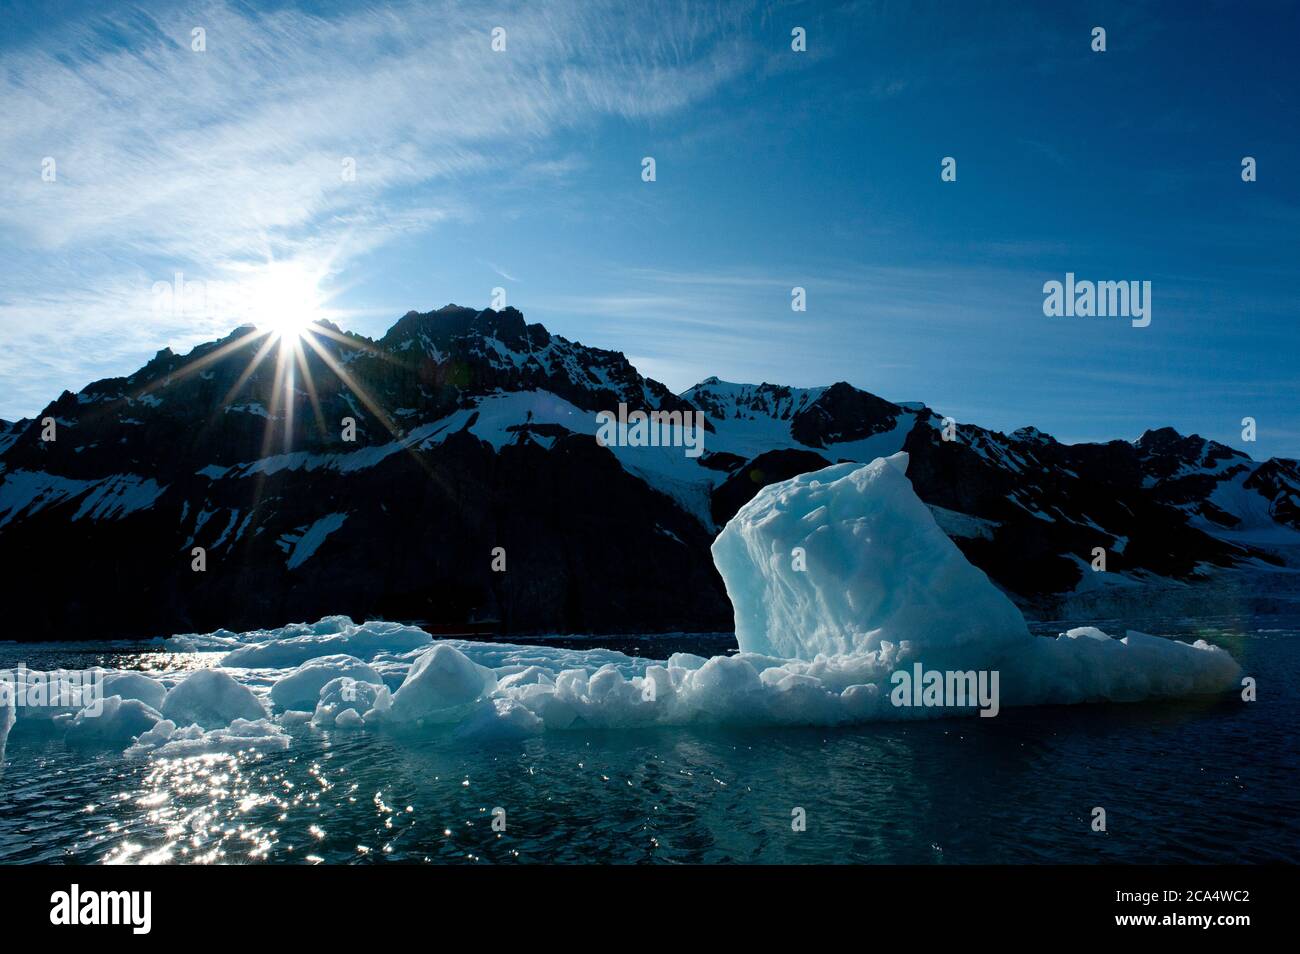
[0,0,1300,458]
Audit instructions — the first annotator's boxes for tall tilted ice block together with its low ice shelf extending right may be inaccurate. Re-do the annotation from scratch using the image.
[712,452,1242,715]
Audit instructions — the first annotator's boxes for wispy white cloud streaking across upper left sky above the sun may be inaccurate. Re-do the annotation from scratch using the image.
[0,1,753,415]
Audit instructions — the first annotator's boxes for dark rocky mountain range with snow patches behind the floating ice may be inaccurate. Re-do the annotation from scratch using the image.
[0,305,1300,638]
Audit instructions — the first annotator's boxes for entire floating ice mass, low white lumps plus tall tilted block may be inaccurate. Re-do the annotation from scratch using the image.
[0,454,1242,758]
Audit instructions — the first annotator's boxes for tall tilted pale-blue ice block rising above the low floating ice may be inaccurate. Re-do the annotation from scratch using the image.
[712,454,1028,663]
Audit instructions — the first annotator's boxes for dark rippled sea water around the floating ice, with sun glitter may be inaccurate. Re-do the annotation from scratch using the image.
[0,616,1300,864]
